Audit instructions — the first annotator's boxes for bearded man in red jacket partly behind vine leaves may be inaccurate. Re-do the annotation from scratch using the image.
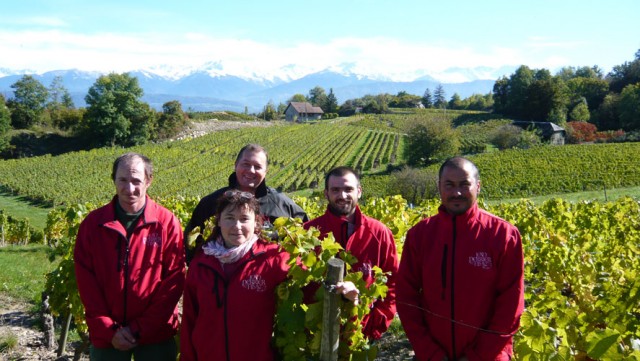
[304,167,398,340]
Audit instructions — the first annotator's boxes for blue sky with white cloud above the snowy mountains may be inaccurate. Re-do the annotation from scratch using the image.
[0,0,640,81]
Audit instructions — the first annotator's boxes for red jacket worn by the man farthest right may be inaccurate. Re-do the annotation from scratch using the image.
[397,204,524,361]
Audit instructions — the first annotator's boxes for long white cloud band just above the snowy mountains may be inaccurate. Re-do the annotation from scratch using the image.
[0,28,596,81]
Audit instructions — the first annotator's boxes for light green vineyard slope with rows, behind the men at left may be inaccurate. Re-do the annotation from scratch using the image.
[0,119,401,206]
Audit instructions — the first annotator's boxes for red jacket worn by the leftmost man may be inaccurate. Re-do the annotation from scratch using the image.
[74,197,185,347]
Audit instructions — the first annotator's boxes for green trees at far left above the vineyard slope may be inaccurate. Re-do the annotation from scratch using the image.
[0,73,187,151]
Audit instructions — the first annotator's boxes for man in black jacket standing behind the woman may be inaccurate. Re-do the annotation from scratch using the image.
[184,144,309,262]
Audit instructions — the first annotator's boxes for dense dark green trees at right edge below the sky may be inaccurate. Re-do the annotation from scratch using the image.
[493,50,640,131]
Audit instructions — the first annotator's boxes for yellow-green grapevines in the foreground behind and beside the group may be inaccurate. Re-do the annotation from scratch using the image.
[41,196,640,360]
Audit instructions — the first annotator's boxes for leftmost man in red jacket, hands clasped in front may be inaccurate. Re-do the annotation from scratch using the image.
[74,153,185,361]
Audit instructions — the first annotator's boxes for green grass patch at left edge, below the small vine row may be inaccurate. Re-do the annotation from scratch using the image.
[0,245,57,303]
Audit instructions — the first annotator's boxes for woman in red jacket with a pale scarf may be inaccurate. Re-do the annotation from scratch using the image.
[180,190,289,361]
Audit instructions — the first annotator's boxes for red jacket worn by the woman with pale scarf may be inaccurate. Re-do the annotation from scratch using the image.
[180,240,289,361]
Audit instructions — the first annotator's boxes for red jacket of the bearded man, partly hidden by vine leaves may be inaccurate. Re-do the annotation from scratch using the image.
[304,207,398,340]
